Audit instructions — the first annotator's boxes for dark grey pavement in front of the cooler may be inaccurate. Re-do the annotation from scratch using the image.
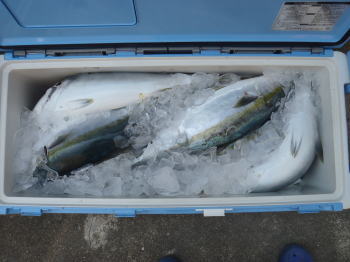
[0,47,350,262]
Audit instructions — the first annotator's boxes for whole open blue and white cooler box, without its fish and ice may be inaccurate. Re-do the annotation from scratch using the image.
[0,0,350,217]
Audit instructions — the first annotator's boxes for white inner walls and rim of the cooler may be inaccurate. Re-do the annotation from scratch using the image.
[0,53,347,209]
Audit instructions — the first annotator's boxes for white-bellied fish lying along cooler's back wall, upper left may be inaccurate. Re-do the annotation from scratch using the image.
[32,72,221,149]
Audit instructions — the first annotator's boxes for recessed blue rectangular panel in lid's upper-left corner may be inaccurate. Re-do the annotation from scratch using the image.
[2,0,136,28]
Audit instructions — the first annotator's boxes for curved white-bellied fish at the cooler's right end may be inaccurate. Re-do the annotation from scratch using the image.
[249,84,323,193]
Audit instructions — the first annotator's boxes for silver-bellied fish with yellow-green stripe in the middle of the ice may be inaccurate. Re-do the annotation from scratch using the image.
[136,76,286,162]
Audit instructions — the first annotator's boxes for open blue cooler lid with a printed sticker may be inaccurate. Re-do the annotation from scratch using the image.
[0,0,350,48]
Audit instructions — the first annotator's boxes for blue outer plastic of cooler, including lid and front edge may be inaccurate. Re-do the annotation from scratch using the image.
[0,0,350,217]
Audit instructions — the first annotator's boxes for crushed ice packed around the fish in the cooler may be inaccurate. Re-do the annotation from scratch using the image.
[14,69,318,197]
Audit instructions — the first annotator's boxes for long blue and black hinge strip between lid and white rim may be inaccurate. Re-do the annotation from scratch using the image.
[5,46,331,59]
